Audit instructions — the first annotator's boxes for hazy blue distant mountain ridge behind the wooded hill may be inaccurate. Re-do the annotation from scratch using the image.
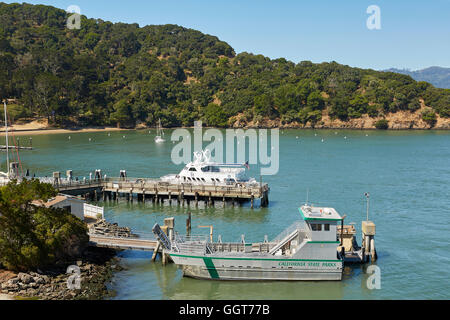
[385,67,450,89]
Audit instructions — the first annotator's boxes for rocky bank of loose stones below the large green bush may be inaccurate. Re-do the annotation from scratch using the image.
[0,248,122,300]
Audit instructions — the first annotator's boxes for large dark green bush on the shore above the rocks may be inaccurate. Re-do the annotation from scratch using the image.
[0,180,89,271]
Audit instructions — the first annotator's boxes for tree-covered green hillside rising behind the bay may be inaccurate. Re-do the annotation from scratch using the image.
[0,3,450,127]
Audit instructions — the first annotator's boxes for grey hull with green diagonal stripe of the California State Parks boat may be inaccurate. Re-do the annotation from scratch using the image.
[171,255,342,281]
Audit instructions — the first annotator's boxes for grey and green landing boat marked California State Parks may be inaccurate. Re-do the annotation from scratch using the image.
[154,205,343,281]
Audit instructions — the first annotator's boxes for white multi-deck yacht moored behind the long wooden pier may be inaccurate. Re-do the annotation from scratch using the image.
[161,150,258,185]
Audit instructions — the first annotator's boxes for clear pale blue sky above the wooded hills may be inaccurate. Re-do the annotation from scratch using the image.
[6,0,450,70]
